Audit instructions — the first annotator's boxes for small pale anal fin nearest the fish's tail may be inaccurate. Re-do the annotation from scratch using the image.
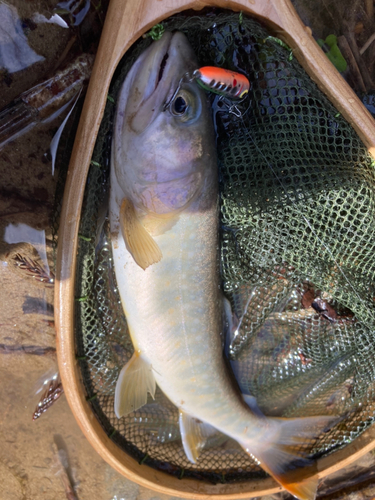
[179,410,217,464]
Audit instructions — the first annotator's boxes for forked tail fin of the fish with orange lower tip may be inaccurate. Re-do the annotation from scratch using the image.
[240,417,340,500]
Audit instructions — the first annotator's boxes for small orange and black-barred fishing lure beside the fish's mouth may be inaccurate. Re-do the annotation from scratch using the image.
[193,66,250,99]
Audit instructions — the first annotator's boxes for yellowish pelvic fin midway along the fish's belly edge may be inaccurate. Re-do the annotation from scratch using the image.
[115,353,156,418]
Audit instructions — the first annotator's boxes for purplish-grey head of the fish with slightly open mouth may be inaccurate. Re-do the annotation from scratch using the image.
[112,32,217,214]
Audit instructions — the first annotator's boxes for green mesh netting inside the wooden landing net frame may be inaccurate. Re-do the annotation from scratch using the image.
[72,10,375,482]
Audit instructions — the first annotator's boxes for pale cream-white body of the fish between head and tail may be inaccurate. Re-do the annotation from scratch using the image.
[111,189,252,438]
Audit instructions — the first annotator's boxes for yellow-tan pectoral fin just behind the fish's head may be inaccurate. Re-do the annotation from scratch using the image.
[120,198,162,269]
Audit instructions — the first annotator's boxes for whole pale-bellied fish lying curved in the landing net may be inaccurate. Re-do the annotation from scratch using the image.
[109,32,332,500]
